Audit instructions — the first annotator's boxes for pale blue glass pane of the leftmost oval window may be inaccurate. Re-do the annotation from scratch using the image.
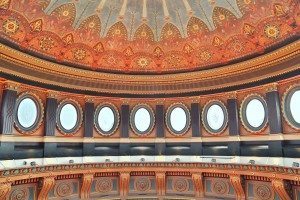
[17,98,38,128]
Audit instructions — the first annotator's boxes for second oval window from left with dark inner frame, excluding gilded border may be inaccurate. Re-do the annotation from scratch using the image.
[58,102,80,133]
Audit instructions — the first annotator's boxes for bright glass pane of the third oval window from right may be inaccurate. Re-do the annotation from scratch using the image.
[206,104,225,131]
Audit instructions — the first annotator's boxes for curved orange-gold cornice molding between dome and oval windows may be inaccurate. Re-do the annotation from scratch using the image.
[0,40,300,96]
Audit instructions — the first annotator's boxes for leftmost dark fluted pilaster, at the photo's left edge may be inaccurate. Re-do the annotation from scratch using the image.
[0,90,17,135]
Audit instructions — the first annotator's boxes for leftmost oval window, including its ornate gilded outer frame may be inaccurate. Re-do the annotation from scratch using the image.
[15,93,43,133]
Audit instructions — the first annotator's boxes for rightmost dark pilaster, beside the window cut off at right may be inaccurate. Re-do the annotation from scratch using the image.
[266,91,282,134]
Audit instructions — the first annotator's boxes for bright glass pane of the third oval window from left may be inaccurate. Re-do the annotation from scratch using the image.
[98,107,115,132]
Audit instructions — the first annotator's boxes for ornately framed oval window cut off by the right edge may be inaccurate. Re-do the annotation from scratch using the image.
[283,86,300,129]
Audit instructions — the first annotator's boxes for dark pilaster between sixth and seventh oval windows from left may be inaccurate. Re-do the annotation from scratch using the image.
[227,99,239,135]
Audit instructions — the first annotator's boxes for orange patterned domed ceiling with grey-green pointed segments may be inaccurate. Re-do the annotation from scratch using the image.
[0,0,300,73]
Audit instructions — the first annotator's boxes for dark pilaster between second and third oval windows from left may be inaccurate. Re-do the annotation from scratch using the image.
[84,102,94,137]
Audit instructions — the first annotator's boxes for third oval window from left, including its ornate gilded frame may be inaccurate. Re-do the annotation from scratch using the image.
[95,104,119,136]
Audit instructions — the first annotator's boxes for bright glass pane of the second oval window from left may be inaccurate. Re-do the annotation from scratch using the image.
[59,103,78,130]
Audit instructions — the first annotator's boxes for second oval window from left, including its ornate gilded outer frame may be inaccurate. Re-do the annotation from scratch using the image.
[56,100,82,134]
